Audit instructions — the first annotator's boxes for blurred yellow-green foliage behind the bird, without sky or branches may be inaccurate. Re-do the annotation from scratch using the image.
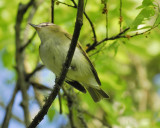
[0,0,160,128]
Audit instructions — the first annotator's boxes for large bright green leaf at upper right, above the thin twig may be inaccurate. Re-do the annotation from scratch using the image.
[131,7,155,29]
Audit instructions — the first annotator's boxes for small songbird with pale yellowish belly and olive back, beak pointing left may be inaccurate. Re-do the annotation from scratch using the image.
[30,23,109,102]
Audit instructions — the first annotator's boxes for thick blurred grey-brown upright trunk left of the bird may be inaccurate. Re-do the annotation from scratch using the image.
[15,0,35,126]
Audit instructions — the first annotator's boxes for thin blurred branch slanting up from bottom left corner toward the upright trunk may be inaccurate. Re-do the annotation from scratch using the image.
[2,85,18,128]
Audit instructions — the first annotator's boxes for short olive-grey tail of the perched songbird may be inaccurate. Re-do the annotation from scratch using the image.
[87,87,109,102]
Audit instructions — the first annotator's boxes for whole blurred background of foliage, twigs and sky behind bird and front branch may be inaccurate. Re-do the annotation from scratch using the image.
[0,0,160,128]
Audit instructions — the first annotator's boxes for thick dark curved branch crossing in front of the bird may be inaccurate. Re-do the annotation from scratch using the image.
[28,0,84,128]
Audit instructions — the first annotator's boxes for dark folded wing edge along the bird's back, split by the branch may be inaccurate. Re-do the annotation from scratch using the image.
[64,33,101,85]
